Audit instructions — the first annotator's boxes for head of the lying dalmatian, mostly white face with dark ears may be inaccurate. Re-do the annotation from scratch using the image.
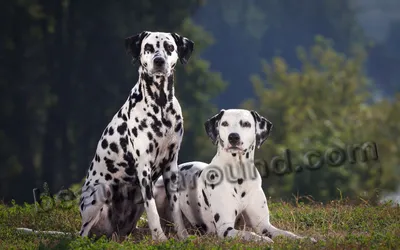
[204,109,272,153]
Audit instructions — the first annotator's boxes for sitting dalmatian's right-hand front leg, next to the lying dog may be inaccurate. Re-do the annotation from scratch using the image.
[163,159,188,239]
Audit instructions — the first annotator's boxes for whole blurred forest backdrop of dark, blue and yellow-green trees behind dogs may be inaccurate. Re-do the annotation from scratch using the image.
[0,0,400,203]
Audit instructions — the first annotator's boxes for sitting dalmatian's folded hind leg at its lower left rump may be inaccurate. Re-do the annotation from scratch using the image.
[79,184,112,237]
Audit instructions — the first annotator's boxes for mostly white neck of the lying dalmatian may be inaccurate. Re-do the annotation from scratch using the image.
[211,144,254,168]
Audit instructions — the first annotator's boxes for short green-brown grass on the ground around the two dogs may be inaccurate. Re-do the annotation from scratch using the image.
[0,197,400,249]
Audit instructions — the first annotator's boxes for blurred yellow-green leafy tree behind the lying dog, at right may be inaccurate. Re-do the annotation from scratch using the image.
[243,37,399,204]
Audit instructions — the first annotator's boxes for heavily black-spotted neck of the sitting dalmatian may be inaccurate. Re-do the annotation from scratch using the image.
[132,66,175,108]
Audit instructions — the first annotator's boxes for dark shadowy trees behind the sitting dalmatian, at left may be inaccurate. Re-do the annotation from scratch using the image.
[0,0,223,202]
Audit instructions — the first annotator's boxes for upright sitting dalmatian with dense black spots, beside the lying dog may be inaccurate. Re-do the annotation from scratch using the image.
[80,31,194,240]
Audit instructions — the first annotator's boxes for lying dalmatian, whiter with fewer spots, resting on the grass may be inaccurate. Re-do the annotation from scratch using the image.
[154,109,315,242]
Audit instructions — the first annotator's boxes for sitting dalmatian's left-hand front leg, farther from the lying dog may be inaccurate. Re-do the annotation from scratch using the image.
[137,163,168,241]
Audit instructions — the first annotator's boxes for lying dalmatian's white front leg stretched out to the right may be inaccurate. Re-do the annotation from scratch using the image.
[244,187,316,242]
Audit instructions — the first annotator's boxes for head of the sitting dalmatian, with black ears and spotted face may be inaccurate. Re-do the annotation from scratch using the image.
[125,31,194,75]
